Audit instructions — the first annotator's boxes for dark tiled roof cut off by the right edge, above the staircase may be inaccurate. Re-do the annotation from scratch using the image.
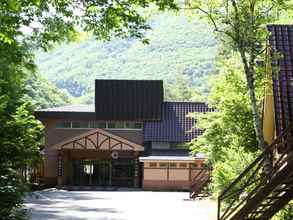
[268,25,293,134]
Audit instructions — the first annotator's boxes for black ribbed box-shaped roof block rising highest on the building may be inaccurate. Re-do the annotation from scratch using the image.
[95,80,163,120]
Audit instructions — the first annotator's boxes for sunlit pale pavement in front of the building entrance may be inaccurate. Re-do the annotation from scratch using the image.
[25,189,216,220]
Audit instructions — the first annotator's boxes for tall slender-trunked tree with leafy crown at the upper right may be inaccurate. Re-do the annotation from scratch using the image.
[187,0,292,175]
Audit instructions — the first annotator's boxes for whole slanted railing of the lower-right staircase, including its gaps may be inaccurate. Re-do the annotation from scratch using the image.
[217,124,293,220]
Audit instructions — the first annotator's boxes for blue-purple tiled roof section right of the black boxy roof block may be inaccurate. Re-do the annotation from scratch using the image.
[144,102,211,142]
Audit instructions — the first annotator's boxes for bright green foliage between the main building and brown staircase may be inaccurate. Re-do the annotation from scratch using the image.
[191,55,262,195]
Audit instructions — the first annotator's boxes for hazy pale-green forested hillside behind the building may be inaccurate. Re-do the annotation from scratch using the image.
[37,14,217,103]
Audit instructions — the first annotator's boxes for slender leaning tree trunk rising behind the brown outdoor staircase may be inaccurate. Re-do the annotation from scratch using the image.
[240,50,272,178]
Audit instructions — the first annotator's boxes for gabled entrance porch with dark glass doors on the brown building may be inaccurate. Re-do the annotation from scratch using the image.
[54,129,144,187]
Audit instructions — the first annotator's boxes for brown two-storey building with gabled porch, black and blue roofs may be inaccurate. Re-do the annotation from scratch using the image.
[35,80,211,189]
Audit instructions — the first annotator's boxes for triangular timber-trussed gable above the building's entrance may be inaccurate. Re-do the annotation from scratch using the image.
[53,128,144,151]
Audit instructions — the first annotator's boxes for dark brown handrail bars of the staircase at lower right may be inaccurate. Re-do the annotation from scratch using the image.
[218,123,293,220]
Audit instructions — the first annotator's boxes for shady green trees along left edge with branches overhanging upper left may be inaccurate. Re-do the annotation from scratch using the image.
[0,0,176,220]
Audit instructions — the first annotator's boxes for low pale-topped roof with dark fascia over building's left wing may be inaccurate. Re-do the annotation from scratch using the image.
[35,105,96,120]
